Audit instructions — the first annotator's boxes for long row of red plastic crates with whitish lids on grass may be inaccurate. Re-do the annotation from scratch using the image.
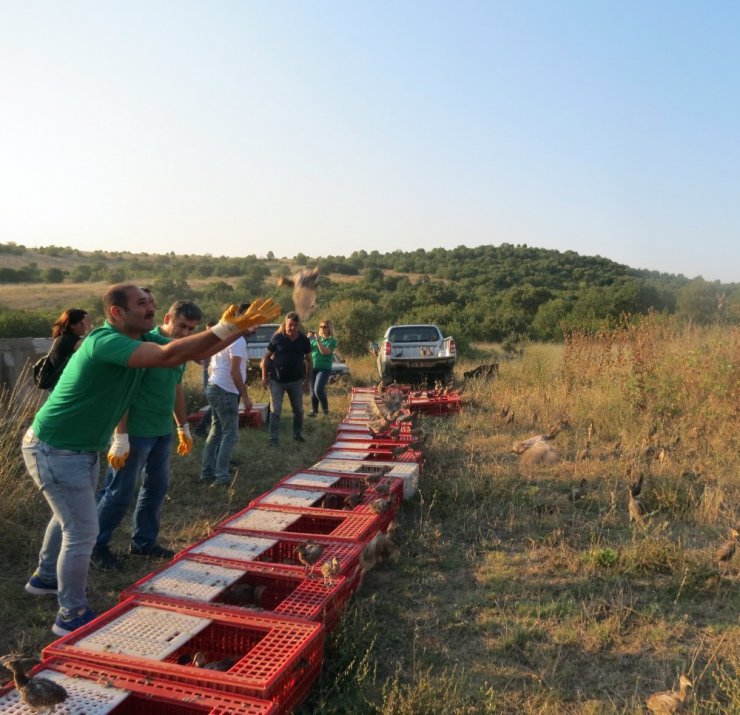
[5,388,448,715]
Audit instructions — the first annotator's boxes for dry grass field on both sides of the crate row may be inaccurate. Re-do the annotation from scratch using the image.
[0,317,740,715]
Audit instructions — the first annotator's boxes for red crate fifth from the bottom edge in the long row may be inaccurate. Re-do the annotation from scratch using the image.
[216,503,378,541]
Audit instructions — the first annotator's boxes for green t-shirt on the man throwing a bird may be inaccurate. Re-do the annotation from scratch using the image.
[33,322,146,452]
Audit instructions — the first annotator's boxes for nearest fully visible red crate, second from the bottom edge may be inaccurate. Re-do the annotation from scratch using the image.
[43,597,325,712]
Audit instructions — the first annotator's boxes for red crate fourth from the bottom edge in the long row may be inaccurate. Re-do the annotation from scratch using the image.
[173,529,364,578]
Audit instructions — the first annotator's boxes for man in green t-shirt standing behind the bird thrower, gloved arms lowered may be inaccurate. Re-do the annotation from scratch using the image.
[91,300,203,571]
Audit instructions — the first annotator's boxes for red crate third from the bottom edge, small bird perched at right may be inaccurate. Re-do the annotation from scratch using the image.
[120,560,352,628]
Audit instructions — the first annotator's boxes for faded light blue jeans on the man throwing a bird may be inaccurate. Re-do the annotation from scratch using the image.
[21,428,100,618]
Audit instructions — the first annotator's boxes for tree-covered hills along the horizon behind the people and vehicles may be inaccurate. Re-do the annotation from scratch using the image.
[0,244,740,352]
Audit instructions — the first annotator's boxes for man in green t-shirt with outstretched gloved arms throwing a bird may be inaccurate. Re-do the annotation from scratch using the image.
[22,283,280,635]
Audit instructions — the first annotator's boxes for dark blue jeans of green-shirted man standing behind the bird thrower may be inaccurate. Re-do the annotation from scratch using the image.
[95,433,172,551]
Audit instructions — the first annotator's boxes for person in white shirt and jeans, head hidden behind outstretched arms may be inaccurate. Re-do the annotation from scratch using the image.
[199,303,252,486]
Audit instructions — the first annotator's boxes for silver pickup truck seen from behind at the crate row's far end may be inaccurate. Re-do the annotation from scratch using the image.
[377,324,457,383]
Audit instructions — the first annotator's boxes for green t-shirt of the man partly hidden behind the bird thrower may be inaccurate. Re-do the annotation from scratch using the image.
[126,328,185,437]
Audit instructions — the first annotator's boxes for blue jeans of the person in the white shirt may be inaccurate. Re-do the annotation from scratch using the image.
[200,385,239,484]
